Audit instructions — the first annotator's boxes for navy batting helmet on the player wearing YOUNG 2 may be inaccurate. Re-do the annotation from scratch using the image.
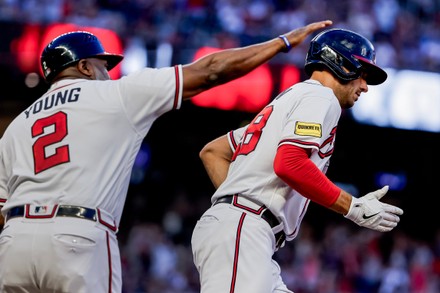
[40,31,124,82]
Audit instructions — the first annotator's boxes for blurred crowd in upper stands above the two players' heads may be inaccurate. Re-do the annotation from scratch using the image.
[0,0,440,71]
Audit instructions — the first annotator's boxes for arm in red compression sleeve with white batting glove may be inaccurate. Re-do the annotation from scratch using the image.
[274,145,403,232]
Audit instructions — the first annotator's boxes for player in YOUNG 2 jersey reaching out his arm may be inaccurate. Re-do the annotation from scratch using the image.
[0,21,331,293]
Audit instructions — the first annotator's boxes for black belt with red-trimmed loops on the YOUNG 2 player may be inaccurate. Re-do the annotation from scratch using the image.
[5,205,117,231]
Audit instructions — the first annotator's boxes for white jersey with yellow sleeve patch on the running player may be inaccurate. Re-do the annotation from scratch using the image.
[212,80,341,240]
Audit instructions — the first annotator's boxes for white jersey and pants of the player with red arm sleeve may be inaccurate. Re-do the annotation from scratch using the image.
[192,80,341,293]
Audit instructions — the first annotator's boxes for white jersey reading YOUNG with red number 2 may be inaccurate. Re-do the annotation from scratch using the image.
[0,65,182,225]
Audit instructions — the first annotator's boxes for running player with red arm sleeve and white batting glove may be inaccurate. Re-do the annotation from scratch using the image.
[192,29,403,293]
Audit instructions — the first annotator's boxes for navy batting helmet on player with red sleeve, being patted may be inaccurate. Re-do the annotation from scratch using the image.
[304,28,387,85]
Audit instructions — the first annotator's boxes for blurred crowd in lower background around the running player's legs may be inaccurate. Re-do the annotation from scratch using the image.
[122,221,440,293]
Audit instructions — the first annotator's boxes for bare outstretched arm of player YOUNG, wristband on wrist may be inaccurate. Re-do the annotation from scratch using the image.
[183,20,332,100]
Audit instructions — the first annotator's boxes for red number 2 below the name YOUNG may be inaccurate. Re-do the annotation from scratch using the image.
[32,112,70,174]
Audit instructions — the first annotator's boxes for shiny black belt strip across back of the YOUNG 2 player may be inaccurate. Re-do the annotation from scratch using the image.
[6,205,97,222]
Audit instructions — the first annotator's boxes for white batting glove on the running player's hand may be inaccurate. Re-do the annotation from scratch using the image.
[345,185,403,232]
